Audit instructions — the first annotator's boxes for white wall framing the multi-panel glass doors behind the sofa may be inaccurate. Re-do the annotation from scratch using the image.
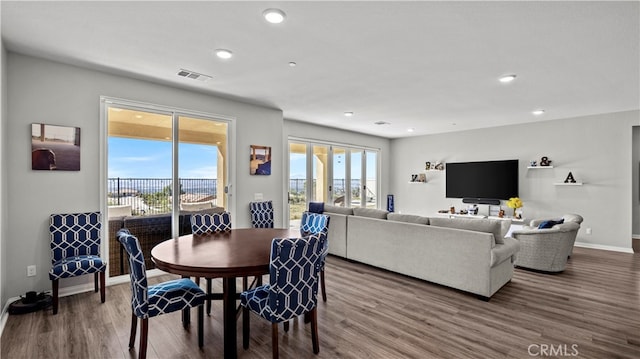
[283,120,391,209]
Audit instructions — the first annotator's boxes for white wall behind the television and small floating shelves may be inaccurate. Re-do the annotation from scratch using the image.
[390,111,640,250]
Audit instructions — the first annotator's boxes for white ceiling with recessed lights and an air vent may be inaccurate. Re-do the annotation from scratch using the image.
[0,1,640,138]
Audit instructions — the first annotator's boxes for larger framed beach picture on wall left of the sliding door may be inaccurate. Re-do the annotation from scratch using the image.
[31,123,80,171]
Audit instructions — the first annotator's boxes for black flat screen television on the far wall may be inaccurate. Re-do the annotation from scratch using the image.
[445,160,518,204]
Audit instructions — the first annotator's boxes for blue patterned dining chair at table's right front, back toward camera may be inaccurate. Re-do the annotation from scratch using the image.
[240,233,326,359]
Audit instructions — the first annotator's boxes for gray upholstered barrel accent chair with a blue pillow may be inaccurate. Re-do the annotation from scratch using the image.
[511,214,582,272]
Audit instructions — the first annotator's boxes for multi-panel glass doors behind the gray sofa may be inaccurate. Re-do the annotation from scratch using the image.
[289,140,379,227]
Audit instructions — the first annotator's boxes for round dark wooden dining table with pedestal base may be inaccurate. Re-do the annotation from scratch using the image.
[151,228,300,358]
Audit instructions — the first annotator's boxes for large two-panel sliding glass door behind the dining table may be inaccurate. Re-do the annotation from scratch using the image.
[103,102,228,276]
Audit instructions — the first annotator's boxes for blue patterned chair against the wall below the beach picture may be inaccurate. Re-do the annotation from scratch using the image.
[49,212,107,314]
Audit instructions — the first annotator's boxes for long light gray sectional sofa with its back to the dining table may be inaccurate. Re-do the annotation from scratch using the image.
[324,205,519,299]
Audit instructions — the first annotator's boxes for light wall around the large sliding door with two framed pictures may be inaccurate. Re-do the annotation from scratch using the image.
[2,52,284,299]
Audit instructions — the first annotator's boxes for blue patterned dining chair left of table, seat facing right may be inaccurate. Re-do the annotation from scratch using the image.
[117,229,206,359]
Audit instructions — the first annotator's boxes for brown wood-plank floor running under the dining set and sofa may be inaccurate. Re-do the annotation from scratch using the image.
[1,248,640,359]
